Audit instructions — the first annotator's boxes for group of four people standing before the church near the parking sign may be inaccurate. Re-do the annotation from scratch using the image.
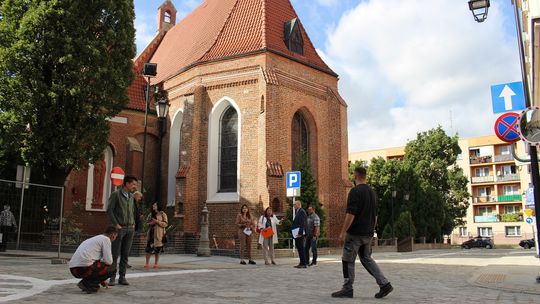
[236,200,321,268]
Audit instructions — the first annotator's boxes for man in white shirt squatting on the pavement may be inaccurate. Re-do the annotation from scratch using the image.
[69,226,118,293]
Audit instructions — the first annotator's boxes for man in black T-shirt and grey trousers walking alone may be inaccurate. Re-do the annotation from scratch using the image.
[332,167,394,298]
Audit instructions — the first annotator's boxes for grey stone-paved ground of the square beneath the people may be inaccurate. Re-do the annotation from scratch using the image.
[0,251,540,304]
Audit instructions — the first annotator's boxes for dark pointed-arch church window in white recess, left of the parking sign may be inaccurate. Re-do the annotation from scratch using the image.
[218,107,238,192]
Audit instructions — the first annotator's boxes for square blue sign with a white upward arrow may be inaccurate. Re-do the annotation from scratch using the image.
[491,81,525,114]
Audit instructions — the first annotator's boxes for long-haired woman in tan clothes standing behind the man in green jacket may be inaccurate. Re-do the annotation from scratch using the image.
[144,202,169,269]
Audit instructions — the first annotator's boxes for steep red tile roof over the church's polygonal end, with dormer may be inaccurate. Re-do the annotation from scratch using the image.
[150,0,336,83]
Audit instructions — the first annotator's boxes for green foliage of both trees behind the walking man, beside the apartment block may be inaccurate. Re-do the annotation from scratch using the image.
[360,127,470,241]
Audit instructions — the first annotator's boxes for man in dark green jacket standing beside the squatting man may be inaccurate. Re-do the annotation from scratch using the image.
[107,175,138,286]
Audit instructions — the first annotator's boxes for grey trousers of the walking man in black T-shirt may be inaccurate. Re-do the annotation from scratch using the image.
[341,233,388,289]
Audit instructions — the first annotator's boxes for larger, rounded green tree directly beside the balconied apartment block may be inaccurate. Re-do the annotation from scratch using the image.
[404,126,469,240]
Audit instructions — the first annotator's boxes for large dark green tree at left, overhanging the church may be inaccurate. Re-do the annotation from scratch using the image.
[0,0,135,185]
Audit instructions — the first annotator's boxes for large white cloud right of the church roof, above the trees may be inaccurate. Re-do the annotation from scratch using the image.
[319,0,520,151]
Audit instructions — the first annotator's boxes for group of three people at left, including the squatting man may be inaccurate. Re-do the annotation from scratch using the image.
[69,175,168,293]
